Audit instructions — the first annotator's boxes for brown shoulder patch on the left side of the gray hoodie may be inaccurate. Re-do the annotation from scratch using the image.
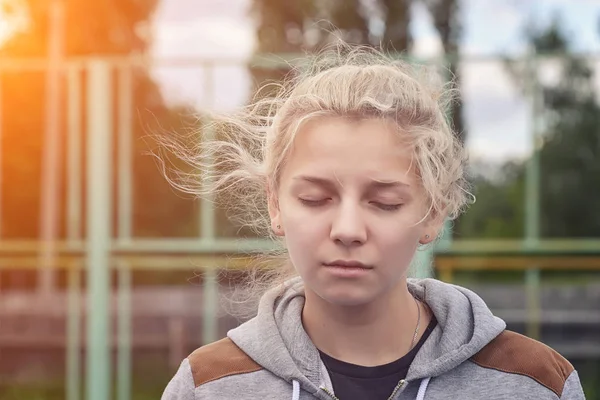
[188,338,262,387]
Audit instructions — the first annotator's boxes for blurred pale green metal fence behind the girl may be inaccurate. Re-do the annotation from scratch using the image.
[0,57,600,400]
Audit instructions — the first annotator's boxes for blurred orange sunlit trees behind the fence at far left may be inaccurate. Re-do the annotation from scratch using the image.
[0,0,198,244]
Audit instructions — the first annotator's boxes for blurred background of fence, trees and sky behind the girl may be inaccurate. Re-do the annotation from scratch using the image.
[0,0,600,400]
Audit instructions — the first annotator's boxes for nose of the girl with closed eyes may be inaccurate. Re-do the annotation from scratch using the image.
[330,202,367,247]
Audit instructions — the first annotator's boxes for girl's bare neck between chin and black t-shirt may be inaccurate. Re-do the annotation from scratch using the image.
[302,280,429,366]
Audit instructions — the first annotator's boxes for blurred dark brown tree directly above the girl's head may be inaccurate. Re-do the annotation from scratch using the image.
[250,0,412,94]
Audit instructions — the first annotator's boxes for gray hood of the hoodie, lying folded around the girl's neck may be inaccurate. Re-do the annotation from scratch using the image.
[228,278,506,398]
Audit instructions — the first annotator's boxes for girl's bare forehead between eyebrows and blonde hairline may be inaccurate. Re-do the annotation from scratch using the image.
[282,117,417,186]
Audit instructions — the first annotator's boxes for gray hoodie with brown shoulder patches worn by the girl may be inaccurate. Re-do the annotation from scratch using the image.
[162,278,585,400]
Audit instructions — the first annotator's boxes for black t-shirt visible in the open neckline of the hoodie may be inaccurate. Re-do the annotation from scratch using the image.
[320,317,437,400]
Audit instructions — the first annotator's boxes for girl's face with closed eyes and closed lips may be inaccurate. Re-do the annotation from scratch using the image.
[270,117,436,305]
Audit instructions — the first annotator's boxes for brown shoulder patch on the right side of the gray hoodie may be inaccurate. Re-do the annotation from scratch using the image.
[471,331,573,397]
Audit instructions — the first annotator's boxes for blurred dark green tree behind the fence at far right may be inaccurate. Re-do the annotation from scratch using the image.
[461,20,600,238]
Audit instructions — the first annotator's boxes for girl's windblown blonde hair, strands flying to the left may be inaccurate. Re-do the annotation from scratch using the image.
[158,42,472,318]
